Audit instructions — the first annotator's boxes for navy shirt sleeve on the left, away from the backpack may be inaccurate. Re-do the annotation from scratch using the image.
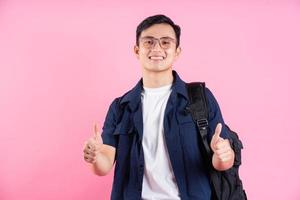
[101,98,118,147]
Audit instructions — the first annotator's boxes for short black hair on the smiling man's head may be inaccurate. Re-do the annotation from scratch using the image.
[136,15,180,48]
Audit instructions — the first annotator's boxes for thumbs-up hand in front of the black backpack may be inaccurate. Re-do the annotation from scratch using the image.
[210,123,234,164]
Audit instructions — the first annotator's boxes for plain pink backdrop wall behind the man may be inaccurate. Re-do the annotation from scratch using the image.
[0,0,300,200]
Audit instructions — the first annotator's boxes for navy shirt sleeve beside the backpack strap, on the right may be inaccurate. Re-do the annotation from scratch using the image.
[205,88,229,142]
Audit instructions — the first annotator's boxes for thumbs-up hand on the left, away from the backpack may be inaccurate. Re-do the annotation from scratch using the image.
[83,123,103,164]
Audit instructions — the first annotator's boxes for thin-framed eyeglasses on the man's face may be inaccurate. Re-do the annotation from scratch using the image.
[140,36,176,49]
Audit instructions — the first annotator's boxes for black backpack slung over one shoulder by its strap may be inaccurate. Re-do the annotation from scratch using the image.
[187,82,247,200]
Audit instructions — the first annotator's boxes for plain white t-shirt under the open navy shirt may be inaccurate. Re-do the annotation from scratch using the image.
[141,84,180,200]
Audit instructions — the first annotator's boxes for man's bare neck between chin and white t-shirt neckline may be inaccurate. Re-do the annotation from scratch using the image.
[143,68,173,88]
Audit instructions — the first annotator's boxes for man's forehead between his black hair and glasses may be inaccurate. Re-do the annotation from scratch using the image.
[141,24,175,38]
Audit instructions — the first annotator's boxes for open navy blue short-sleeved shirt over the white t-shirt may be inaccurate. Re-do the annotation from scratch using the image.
[102,71,228,200]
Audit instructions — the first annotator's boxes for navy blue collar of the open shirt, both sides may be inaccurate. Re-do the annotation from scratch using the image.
[120,70,188,110]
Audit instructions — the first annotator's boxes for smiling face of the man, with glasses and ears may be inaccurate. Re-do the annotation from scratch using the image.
[134,24,181,72]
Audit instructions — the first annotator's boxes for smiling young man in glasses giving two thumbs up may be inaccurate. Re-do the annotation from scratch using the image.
[84,15,234,200]
